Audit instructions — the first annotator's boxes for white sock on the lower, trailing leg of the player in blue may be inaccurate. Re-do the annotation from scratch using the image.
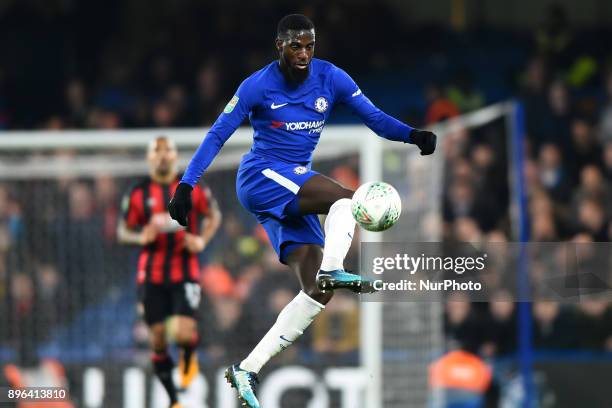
[240,291,325,373]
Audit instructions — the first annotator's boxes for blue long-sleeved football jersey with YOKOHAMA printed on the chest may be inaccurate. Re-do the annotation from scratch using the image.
[182,58,412,186]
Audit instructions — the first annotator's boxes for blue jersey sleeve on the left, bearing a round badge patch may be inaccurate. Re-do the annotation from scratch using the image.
[181,78,253,187]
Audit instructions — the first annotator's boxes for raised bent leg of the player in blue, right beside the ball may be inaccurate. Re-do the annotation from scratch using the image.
[298,174,373,293]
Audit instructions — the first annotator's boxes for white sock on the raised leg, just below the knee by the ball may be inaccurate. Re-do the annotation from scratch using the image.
[321,198,355,271]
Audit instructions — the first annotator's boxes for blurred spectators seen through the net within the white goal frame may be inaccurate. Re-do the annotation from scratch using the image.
[0,157,359,365]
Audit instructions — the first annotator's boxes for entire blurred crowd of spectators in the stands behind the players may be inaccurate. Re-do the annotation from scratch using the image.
[0,1,612,374]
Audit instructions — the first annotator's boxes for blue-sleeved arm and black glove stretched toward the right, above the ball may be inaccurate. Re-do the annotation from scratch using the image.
[334,68,437,156]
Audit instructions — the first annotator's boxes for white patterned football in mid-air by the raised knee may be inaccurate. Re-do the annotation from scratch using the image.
[351,181,402,232]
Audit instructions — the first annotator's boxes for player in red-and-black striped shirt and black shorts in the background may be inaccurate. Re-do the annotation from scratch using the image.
[117,136,221,408]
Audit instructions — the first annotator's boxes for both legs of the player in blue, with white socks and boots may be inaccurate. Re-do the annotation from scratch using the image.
[226,174,370,407]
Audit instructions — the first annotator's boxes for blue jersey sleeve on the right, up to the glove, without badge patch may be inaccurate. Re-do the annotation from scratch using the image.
[333,67,413,143]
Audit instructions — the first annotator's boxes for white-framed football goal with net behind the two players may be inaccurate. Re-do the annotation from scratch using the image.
[0,100,512,408]
